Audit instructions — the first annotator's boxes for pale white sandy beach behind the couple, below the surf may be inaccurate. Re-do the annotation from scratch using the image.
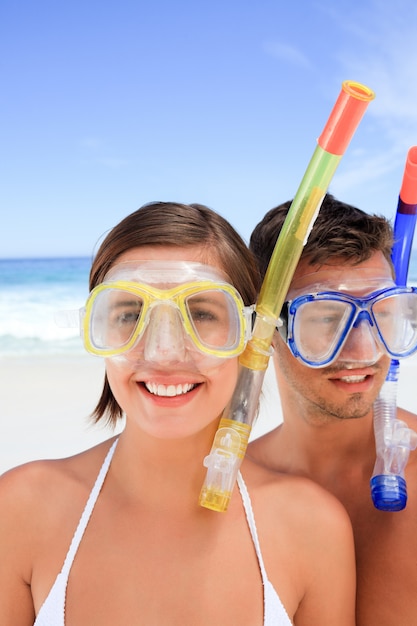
[0,354,417,473]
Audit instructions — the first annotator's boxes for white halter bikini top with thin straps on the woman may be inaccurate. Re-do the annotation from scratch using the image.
[34,439,292,626]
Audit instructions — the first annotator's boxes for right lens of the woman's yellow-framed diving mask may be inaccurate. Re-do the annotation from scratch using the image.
[185,289,243,352]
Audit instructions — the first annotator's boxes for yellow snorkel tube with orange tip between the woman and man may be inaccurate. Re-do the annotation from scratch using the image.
[200,81,375,512]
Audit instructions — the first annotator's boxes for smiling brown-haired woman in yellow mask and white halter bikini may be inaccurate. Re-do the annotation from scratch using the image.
[0,203,355,626]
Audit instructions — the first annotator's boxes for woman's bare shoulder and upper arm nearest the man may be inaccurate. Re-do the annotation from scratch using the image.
[242,460,355,624]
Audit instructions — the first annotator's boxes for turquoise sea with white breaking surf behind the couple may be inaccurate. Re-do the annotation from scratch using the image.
[0,249,417,358]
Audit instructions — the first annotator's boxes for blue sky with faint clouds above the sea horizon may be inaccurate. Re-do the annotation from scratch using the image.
[0,0,417,258]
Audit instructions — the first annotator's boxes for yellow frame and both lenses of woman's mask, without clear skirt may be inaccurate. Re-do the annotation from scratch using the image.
[83,281,246,358]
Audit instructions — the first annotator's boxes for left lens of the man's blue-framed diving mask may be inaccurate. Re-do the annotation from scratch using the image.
[290,299,354,365]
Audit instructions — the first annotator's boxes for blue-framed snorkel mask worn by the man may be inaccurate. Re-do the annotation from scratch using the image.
[277,281,417,368]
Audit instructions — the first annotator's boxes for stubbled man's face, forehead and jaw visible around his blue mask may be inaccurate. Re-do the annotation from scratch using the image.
[273,252,393,421]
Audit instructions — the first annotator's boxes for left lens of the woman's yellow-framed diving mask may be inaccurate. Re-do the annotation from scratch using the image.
[89,289,144,350]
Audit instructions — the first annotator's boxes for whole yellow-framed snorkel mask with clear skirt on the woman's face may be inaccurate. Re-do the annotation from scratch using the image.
[59,260,254,364]
